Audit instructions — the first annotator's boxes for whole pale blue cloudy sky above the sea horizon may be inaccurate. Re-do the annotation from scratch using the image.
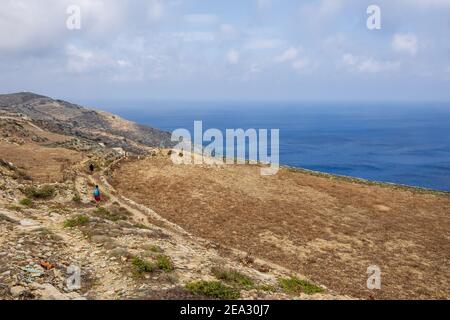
[0,0,450,101]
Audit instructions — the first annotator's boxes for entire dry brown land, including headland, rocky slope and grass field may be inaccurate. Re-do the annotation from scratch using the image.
[0,93,450,300]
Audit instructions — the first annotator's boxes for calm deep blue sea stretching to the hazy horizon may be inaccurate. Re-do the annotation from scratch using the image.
[89,102,450,191]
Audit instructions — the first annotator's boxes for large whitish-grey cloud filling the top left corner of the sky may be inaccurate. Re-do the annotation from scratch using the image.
[0,0,128,53]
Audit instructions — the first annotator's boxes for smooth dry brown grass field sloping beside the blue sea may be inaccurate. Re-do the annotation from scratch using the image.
[111,157,450,299]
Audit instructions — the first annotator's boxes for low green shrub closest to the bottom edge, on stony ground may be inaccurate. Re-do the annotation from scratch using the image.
[186,281,241,300]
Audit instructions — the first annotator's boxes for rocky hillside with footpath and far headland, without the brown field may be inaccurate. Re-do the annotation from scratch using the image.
[0,94,350,300]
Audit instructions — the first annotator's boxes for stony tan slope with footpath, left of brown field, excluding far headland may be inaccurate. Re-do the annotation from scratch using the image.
[0,114,349,299]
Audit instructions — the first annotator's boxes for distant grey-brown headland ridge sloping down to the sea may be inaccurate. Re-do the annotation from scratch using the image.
[0,93,172,153]
